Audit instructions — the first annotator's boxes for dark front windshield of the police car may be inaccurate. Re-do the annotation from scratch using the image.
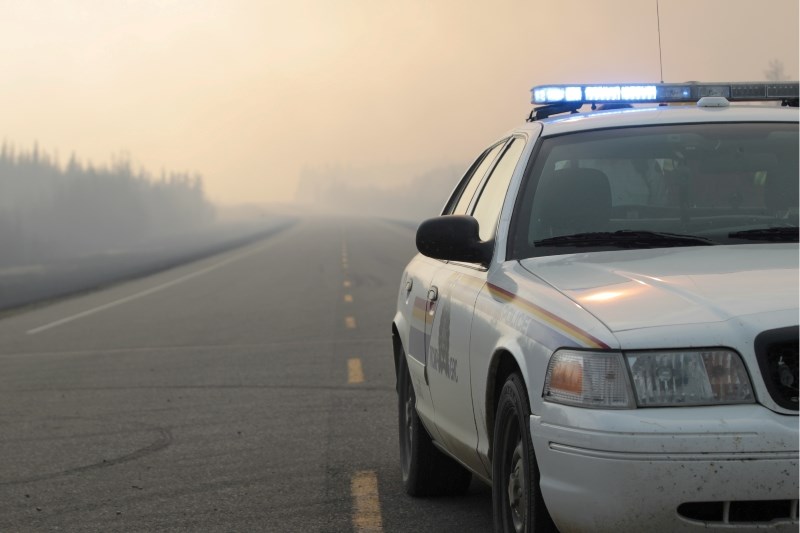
[509,123,798,259]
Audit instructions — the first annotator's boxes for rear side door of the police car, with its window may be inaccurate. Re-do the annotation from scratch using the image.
[398,141,505,442]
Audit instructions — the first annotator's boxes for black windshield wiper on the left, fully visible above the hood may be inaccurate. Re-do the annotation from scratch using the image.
[533,230,718,248]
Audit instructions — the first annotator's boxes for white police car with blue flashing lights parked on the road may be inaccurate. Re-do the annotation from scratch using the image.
[392,83,799,532]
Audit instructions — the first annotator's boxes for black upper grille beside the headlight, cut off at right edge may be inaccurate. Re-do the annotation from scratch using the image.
[755,326,798,411]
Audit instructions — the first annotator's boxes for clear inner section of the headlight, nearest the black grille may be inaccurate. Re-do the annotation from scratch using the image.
[626,349,755,407]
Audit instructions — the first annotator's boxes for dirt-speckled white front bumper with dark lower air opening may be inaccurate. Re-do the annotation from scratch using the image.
[530,403,800,533]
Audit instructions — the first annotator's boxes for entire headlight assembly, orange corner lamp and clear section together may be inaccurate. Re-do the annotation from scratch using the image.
[543,348,755,409]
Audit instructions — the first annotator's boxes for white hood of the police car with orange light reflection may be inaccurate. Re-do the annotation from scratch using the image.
[520,244,799,332]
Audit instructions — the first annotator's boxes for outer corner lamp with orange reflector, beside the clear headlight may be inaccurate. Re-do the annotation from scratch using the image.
[544,350,635,409]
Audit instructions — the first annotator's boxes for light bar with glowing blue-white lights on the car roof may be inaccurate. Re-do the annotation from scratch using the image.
[531,81,800,104]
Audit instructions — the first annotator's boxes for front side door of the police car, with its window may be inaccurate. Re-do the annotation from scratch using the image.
[427,137,525,474]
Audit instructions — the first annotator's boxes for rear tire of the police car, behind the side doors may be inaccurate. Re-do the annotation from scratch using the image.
[397,353,472,497]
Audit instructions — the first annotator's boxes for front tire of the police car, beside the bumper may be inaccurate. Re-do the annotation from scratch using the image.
[492,374,558,533]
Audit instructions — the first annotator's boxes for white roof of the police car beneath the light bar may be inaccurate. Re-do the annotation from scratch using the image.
[518,105,800,137]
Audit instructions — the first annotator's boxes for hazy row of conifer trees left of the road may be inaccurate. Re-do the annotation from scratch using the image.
[0,143,214,267]
